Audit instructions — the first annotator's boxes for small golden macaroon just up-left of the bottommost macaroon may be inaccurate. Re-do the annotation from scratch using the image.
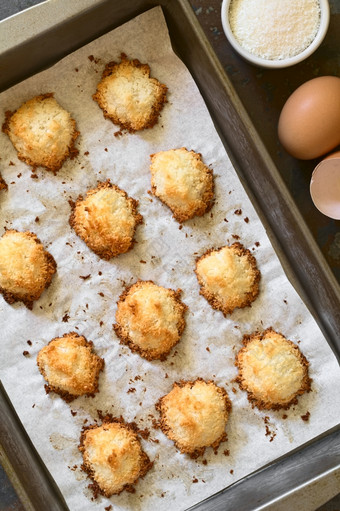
[37,332,104,403]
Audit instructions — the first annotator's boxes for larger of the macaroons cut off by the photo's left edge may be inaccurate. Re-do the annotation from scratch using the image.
[0,229,57,309]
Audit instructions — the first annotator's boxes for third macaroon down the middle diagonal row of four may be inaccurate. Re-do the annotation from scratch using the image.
[113,281,187,360]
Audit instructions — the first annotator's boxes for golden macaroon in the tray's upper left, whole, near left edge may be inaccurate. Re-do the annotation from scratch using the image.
[2,93,79,173]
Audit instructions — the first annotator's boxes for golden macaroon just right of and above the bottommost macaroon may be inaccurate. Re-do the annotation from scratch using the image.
[156,378,231,458]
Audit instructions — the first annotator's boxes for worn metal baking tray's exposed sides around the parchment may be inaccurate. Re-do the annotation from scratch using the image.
[0,0,340,511]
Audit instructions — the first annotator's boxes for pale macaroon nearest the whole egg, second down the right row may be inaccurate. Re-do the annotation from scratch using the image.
[150,147,214,222]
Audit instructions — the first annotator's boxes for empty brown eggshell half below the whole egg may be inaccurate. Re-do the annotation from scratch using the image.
[310,151,340,220]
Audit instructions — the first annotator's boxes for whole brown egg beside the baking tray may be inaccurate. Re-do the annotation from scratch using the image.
[278,76,340,160]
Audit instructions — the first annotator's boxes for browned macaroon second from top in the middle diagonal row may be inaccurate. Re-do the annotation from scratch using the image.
[70,181,143,260]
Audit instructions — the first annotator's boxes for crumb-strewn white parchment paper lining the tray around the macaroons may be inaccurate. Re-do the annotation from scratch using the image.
[0,8,340,511]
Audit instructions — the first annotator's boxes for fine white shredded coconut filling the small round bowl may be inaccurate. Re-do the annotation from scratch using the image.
[229,0,321,60]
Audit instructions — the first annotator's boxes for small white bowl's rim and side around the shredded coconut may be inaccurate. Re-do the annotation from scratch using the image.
[221,0,329,69]
